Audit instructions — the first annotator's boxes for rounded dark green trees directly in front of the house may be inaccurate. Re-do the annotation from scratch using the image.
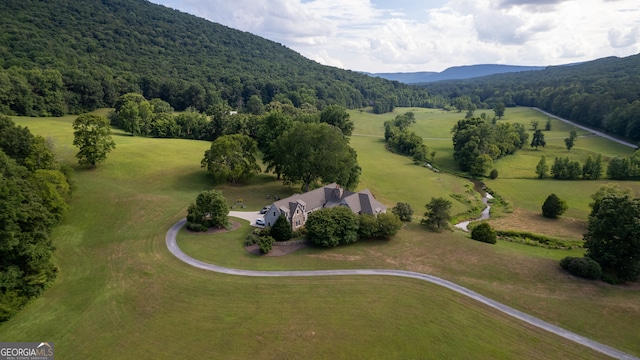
[305,206,402,247]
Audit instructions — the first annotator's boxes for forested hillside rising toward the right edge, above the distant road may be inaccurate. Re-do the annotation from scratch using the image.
[424,55,640,141]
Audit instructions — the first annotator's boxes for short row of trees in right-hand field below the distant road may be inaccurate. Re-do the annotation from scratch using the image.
[536,154,611,180]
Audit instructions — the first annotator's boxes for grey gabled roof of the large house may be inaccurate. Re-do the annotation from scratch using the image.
[273,183,387,215]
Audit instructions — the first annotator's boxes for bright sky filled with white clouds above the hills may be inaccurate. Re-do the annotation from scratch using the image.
[151,0,640,73]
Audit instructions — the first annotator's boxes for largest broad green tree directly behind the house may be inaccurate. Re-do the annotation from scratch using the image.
[273,123,361,191]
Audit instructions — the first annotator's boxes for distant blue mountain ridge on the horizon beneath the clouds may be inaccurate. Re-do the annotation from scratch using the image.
[366,64,545,84]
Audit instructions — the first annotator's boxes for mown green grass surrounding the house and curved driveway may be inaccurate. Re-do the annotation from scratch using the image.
[0,114,640,359]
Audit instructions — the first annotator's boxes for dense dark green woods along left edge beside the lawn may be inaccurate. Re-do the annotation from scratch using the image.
[0,115,73,321]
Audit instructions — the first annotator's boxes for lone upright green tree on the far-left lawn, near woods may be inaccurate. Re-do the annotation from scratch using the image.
[73,114,116,168]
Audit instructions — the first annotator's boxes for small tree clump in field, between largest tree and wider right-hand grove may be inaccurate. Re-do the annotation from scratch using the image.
[384,111,435,164]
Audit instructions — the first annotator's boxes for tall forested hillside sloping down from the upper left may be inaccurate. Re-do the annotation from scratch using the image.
[0,0,427,116]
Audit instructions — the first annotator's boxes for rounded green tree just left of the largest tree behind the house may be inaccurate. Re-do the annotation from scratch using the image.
[200,134,260,182]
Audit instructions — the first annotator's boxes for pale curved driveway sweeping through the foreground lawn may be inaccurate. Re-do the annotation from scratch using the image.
[166,219,640,360]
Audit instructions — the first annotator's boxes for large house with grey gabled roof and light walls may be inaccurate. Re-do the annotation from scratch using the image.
[264,183,387,231]
